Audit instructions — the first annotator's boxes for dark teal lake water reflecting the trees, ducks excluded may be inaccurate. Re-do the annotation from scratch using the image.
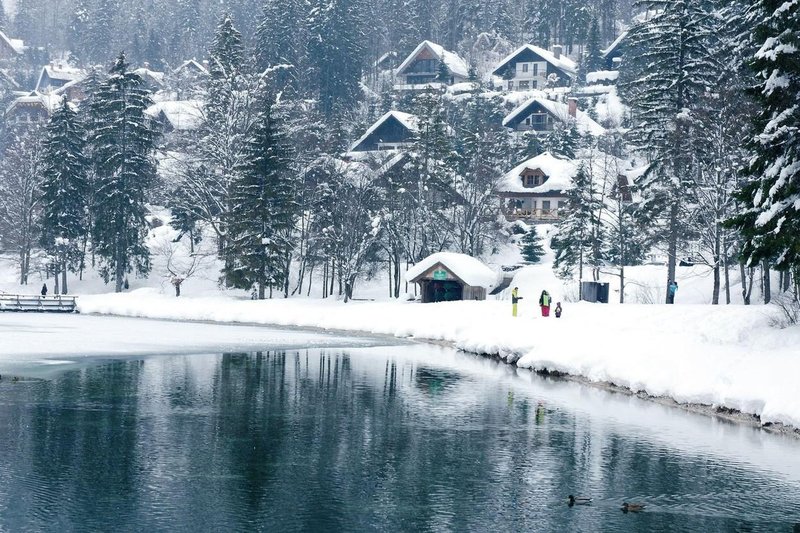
[0,346,800,532]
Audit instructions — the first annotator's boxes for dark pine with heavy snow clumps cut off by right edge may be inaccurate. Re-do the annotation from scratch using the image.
[733,0,800,285]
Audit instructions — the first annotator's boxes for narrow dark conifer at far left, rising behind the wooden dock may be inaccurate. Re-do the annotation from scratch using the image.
[40,98,89,294]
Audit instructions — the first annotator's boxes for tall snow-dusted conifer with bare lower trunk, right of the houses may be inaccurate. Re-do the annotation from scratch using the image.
[620,0,719,299]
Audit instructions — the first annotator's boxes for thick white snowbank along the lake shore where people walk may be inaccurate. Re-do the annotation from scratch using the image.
[79,289,800,428]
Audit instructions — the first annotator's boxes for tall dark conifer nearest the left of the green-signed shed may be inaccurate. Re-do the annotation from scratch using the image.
[225,97,298,299]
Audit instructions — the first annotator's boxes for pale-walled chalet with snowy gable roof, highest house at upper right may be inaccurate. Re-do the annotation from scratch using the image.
[492,44,578,91]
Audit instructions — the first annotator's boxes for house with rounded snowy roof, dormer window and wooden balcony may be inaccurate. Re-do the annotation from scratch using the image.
[497,152,578,222]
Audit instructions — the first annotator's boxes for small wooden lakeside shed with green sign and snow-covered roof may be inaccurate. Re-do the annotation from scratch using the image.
[405,252,497,303]
